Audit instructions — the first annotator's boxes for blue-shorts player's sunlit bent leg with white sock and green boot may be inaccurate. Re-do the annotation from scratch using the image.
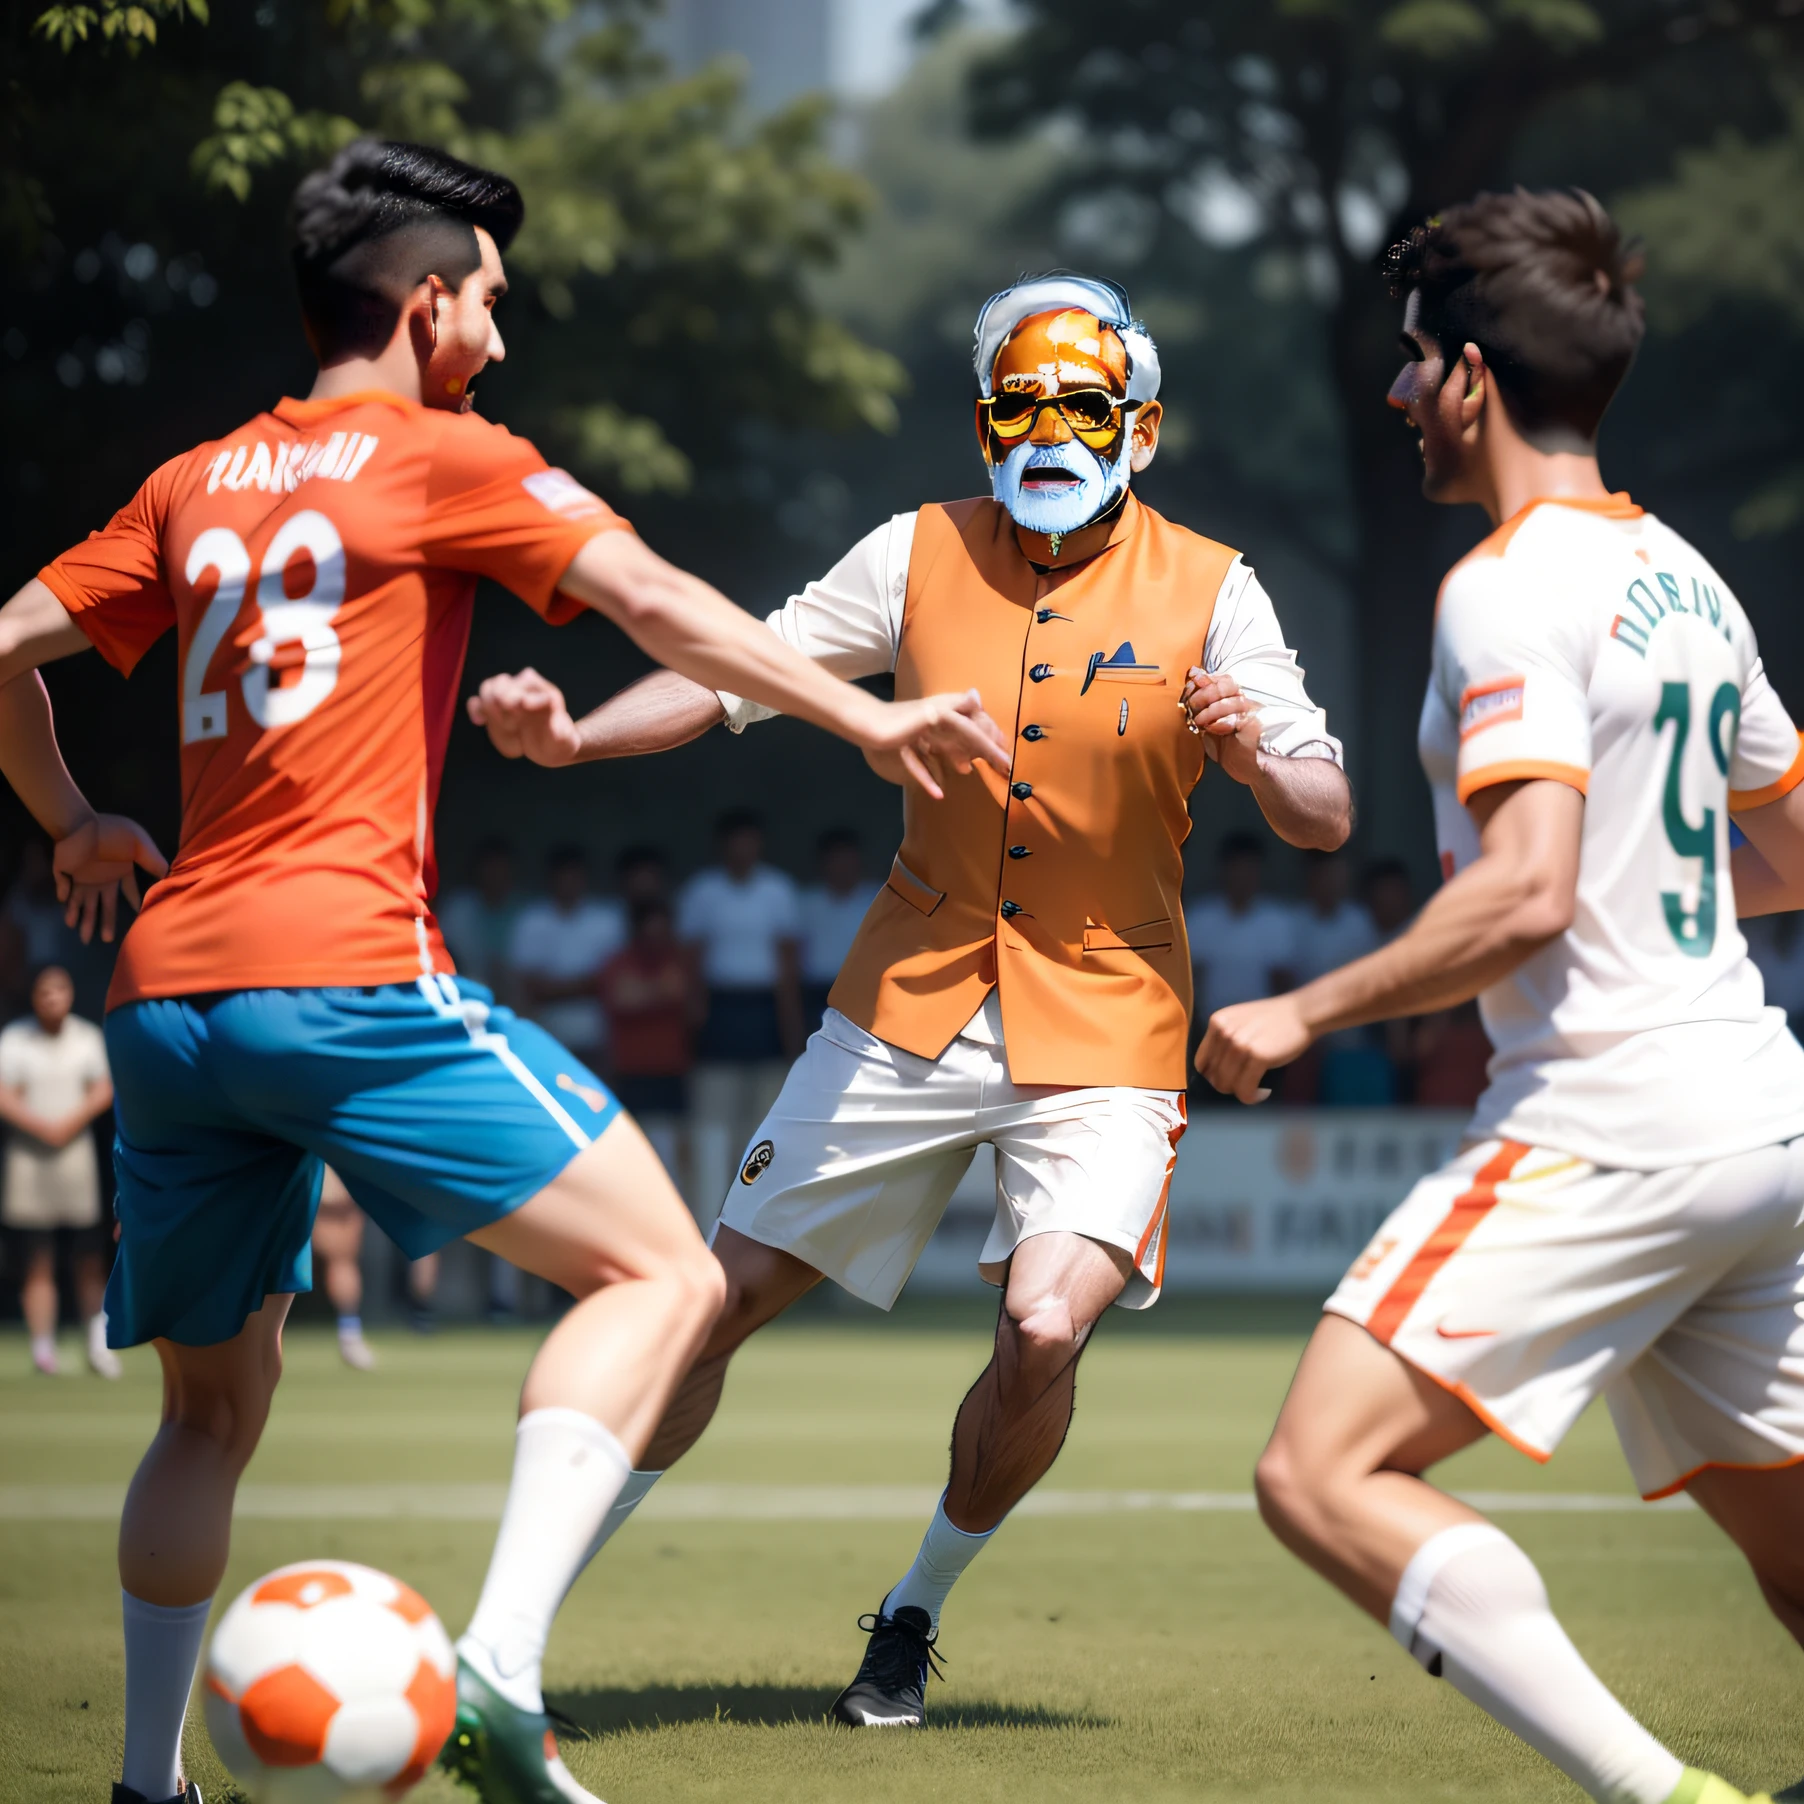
[447,1115,725,1804]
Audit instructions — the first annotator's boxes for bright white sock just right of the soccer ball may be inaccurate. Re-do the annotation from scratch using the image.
[456,1409,633,1710]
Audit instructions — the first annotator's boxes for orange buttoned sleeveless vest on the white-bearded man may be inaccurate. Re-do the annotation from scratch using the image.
[832,494,1236,1090]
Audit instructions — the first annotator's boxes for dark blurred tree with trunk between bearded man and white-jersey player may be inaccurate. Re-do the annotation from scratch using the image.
[971,0,1804,858]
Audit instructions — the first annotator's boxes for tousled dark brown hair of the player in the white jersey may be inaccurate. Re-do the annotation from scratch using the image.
[1385,188,1645,438]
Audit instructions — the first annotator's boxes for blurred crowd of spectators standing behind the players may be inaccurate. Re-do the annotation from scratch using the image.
[17,808,1804,1349]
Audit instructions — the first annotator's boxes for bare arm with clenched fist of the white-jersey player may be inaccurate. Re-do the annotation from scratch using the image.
[1196,779,1584,1102]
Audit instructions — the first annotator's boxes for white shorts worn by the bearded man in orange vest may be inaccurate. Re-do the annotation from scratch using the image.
[720,1008,1183,1310]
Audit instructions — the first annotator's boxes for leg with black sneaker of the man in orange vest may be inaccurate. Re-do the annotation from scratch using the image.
[833,1232,1133,1728]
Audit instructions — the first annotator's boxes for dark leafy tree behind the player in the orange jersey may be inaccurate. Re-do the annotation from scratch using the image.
[0,0,904,876]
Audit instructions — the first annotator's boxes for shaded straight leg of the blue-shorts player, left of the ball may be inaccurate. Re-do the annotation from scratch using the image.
[119,1297,292,1799]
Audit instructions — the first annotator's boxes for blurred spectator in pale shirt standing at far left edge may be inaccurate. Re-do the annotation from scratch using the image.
[0,965,119,1378]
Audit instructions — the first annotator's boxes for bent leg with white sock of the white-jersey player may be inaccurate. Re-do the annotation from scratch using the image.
[1256,1315,1702,1804]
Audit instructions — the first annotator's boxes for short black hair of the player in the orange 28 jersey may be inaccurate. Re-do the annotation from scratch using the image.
[289,137,527,359]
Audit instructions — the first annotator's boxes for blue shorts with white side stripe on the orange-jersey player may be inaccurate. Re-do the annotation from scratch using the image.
[106,976,621,1348]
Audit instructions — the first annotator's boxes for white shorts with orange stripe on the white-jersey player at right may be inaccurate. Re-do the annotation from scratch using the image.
[1326,1140,1804,1497]
